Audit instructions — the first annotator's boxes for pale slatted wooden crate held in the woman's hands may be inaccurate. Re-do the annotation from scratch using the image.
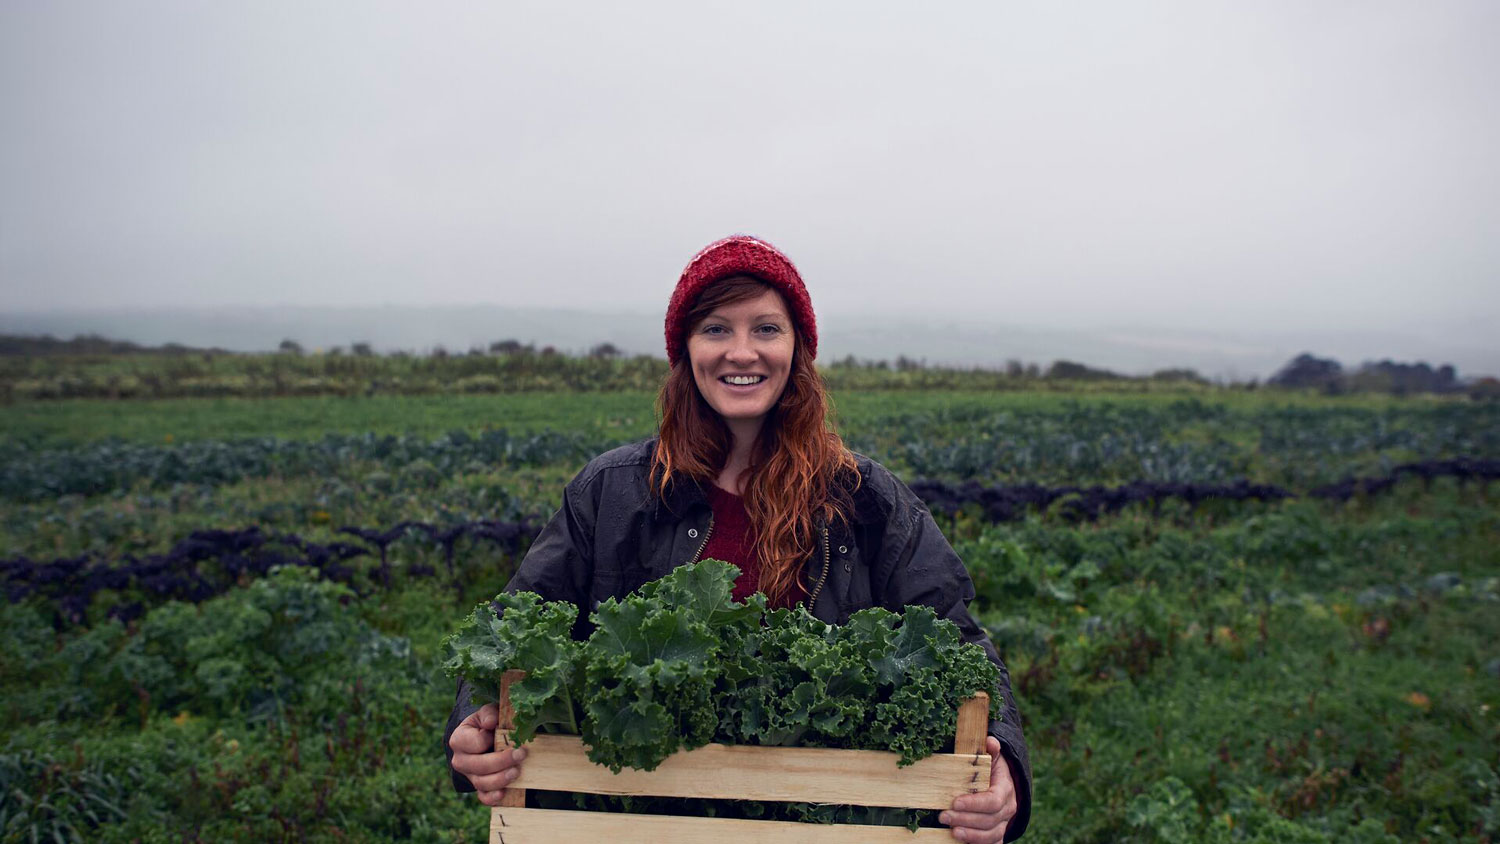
[489,672,990,844]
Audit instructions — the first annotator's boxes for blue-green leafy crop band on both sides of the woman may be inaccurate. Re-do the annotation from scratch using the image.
[11,402,1500,501]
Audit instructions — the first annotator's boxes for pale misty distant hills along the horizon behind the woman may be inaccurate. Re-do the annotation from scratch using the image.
[0,304,1500,381]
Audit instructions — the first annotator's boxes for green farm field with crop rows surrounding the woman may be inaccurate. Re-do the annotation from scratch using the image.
[0,383,1500,843]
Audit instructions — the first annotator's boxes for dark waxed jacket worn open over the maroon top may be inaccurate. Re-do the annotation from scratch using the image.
[443,438,1032,841]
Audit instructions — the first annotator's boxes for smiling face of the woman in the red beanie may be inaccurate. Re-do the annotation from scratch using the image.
[687,288,797,436]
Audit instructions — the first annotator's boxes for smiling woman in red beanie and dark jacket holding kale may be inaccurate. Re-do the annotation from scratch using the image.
[444,235,1031,843]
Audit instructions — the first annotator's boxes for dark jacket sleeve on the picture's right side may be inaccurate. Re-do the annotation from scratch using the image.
[876,490,1032,841]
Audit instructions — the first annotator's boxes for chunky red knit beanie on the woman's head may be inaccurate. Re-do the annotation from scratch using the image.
[666,234,818,366]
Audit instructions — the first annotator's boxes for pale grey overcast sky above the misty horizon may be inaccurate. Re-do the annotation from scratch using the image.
[0,0,1500,367]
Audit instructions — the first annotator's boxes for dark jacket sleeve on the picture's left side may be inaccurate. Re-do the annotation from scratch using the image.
[443,480,594,793]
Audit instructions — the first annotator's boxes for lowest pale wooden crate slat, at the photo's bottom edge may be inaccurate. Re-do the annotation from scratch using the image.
[489,808,953,844]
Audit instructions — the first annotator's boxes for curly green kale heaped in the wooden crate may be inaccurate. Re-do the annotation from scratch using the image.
[444,561,999,772]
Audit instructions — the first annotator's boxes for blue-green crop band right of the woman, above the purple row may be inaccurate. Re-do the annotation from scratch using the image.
[852,400,1500,484]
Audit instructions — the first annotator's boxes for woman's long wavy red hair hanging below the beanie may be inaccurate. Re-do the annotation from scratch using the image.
[651,276,860,606]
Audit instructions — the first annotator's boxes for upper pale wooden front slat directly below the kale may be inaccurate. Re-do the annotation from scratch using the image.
[507,736,990,810]
